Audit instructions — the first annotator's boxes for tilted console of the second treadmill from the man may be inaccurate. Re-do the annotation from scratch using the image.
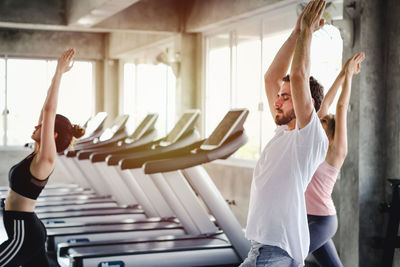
[159,110,200,149]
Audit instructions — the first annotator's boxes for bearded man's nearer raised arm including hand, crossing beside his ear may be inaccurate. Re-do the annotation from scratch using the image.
[290,0,326,129]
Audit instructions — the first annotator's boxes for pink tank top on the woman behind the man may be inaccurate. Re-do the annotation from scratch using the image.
[305,161,339,216]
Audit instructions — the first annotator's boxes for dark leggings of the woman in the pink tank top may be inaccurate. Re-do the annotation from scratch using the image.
[307,215,343,267]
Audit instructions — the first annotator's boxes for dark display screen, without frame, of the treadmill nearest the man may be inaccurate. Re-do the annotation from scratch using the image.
[202,110,244,149]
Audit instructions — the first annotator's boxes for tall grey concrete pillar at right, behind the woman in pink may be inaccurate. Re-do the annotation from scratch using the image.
[339,0,394,266]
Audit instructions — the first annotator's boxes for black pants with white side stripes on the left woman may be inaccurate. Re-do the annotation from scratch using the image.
[0,210,50,267]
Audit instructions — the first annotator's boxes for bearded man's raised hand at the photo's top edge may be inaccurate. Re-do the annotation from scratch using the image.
[300,0,326,32]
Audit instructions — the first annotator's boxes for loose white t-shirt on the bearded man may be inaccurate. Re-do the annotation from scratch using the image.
[246,110,328,266]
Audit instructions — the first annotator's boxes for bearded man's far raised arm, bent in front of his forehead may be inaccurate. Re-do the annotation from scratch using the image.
[264,8,304,119]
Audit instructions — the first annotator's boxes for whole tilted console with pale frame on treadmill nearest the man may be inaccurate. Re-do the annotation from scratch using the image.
[200,109,248,150]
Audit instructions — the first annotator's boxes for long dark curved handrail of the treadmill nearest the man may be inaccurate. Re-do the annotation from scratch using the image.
[142,130,248,174]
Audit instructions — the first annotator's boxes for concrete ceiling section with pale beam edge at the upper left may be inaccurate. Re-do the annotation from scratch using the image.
[0,0,186,34]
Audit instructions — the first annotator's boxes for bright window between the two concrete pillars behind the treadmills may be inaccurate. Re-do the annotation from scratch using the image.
[122,63,176,137]
